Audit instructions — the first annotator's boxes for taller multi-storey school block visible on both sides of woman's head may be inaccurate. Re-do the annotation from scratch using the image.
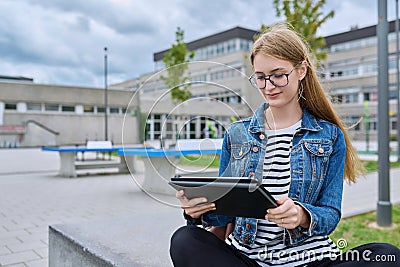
[119,21,397,147]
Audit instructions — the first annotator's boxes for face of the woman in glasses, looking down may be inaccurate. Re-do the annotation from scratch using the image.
[253,54,306,108]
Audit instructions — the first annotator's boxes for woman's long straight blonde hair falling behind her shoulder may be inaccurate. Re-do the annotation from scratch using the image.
[250,23,364,182]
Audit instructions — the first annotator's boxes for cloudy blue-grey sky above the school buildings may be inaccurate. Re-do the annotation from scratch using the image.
[0,0,396,88]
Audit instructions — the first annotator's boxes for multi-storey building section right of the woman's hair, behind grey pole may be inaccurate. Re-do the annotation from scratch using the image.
[321,21,398,140]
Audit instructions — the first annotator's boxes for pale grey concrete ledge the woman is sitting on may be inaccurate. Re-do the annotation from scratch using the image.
[49,213,184,267]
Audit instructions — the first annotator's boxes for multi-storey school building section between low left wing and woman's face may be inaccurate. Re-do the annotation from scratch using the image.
[116,27,262,147]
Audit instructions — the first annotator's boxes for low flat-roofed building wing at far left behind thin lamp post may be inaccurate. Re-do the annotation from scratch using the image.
[0,77,139,147]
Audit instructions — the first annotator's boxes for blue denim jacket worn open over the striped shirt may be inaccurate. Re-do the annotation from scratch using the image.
[202,103,346,245]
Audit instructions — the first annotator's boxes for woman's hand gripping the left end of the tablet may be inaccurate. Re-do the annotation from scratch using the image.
[176,190,216,219]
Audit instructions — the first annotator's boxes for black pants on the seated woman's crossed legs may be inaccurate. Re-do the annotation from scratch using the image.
[170,226,400,267]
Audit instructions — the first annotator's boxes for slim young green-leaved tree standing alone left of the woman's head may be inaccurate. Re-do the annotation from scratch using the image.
[161,27,194,104]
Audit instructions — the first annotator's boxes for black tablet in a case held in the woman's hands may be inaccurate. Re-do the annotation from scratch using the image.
[169,176,278,219]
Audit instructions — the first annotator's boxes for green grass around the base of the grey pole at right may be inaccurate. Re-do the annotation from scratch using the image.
[330,205,400,251]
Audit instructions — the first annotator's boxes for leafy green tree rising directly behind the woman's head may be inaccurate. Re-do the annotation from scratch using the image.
[268,0,335,63]
